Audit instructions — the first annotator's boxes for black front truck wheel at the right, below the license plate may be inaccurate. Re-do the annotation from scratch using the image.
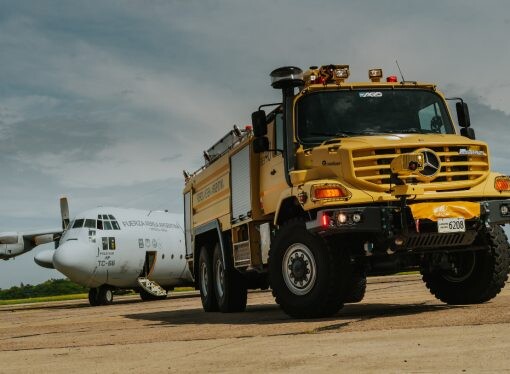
[421,225,510,304]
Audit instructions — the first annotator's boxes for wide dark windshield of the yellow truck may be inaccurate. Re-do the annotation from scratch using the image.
[297,89,454,144]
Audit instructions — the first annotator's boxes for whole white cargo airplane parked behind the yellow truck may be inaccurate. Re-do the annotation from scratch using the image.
[0,198,193,306]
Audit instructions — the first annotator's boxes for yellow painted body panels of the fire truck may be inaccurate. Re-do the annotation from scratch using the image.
[184,78,510,237]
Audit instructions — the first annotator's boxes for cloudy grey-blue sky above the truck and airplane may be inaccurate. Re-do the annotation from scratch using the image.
[0,0,510,288]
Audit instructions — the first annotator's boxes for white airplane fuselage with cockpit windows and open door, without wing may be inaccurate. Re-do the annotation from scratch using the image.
[53,207,192,289]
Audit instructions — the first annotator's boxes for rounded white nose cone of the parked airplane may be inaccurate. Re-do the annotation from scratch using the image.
[53,240,94,286]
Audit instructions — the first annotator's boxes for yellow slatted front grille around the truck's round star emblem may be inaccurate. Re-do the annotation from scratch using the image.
[351,145,489,191]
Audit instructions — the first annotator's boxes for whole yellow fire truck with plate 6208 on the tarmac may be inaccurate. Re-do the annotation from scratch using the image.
[183,65,510,318]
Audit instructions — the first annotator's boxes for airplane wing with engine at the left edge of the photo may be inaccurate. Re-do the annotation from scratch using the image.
[0,229,62,260]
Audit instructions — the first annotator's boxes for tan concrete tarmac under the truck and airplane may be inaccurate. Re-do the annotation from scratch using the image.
[0,275,510,373]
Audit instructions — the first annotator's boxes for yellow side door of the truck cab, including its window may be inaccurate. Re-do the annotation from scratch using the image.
[260,112,287,214]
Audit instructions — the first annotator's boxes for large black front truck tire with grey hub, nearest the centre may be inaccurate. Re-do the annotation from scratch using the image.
[269,219,351,318]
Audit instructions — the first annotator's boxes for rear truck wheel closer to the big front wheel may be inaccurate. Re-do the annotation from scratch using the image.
[213,244,248,313]
